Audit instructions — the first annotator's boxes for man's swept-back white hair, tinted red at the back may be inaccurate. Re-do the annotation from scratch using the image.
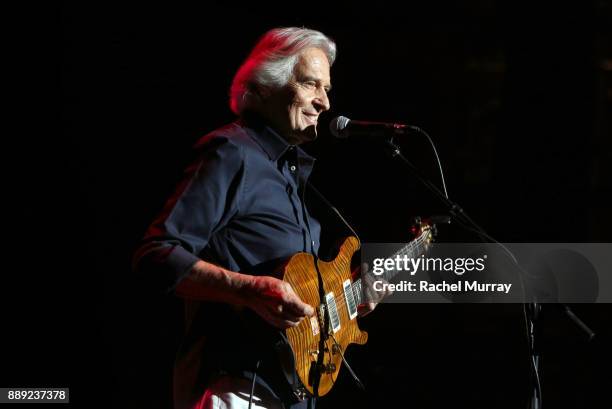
[230,27,336,115]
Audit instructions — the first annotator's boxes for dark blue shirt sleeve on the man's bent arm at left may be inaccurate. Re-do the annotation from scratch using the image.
[133,136,245,292]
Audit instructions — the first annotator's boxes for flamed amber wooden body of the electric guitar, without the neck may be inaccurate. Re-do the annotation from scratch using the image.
[283,237,368,396]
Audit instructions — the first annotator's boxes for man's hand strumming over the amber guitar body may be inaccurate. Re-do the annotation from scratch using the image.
[243,276,315,329]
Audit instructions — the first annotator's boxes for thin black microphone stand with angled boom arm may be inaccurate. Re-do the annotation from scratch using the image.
[385,132,595,409]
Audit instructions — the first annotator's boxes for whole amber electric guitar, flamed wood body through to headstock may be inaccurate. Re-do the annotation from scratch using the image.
[276,222,435,398]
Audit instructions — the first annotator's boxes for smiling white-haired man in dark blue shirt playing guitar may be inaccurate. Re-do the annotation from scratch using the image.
[134,28,358,409]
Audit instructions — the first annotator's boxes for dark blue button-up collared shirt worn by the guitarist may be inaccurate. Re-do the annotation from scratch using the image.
[135,115,320,406]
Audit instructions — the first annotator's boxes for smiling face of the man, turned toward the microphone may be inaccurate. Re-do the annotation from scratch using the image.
[264,48,331,144]
